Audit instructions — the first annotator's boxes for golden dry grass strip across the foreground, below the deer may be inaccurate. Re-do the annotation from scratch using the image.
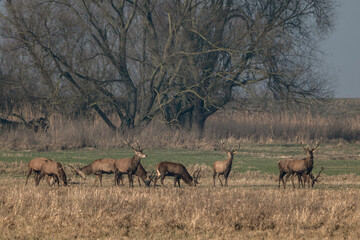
[0,172,360,239]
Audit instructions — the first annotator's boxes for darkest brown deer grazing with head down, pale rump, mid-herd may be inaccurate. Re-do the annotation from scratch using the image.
[154,162,200,187]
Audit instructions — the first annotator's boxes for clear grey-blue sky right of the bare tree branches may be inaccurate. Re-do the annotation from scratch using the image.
[323,0,360,98]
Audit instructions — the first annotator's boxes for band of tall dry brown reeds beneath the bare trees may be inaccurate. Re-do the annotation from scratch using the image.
[0,99,360,151]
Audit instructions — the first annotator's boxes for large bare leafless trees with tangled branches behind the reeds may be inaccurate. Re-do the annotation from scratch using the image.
[0,0,336,131]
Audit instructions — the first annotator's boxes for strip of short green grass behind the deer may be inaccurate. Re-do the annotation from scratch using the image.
[0,144,360,175]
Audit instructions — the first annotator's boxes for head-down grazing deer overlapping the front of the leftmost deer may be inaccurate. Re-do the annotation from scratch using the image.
[36,160,67,186]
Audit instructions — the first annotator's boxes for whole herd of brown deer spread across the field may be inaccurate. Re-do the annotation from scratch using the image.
[25,141,324,188]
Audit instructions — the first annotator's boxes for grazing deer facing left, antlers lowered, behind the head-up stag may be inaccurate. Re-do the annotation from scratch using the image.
[74,158,116,186]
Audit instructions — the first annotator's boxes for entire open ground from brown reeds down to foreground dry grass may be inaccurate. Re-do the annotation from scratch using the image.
[0,99,360,239]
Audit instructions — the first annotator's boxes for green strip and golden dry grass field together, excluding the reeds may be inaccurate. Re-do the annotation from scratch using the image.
[0,144,360,239]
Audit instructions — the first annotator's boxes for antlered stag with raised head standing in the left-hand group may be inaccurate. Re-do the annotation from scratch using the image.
[114,141,146,187]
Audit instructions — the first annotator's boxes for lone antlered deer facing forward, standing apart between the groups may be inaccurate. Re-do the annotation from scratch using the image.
[213,140,240,186]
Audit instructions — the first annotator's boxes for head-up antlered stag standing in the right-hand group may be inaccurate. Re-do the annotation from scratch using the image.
[278,141,319,189]
